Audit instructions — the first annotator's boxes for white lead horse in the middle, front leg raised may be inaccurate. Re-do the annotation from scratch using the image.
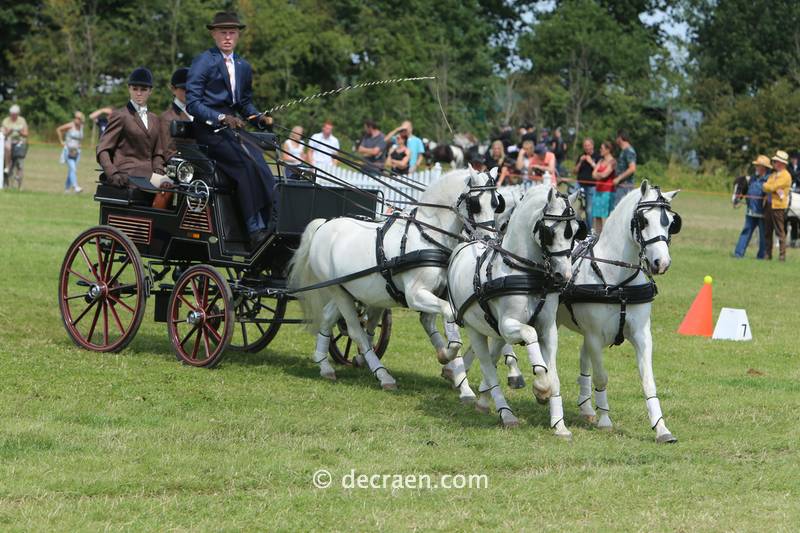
[447,187,585,437]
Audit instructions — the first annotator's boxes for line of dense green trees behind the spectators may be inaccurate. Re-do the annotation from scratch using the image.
[0,0,800,167]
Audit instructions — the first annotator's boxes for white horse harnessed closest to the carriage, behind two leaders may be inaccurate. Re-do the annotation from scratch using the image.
[289,168,498,390]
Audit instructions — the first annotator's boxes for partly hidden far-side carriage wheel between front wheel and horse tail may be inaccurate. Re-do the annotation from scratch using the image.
[230,290,286,353]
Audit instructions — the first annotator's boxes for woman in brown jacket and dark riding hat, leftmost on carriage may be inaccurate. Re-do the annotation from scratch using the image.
[97,67,164,187]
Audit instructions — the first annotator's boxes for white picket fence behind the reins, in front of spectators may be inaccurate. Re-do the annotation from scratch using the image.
[310,163,442,212]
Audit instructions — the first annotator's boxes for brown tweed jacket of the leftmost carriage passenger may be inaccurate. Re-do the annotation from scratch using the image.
[97,102,164,178]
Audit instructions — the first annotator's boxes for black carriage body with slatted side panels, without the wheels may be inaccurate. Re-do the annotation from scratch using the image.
[95,140,377,272]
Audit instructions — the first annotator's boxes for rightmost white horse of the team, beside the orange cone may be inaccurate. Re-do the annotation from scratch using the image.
[496,180,681,443]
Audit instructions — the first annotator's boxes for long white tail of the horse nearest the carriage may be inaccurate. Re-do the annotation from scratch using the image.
[288,218,327,333]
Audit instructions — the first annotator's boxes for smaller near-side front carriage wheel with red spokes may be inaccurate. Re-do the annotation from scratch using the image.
[167,265,234,368]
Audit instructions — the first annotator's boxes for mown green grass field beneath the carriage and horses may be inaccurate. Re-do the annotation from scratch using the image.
[0,143,800,531]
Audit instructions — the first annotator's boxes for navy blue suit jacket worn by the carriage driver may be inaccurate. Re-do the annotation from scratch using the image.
[186,46,261,127]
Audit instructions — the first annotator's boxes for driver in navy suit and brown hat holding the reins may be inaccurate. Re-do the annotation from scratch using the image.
[186,12,275,247]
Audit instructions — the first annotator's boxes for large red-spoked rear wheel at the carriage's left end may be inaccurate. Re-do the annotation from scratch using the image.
[58,226,147,352]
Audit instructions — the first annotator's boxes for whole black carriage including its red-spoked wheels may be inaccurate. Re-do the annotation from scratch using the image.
[59,123,391,367]
